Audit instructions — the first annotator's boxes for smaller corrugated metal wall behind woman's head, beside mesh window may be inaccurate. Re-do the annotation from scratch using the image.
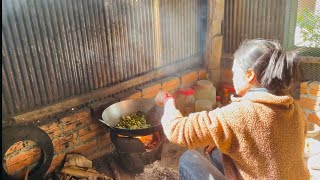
[223,0,287,53]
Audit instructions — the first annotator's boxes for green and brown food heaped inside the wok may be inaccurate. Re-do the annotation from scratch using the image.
[116,111,150,129]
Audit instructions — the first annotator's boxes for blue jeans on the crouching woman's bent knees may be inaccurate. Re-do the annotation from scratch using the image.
[179,148,225,180]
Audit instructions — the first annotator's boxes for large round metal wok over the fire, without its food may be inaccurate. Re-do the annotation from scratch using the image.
[100,98,163,136]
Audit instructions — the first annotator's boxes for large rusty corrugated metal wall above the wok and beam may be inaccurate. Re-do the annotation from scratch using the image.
[2,0,200,115]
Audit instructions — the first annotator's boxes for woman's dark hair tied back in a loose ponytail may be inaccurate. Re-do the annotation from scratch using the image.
[234,39,300,94]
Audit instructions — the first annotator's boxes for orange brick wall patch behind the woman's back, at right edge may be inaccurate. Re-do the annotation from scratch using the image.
[299,81,320,126]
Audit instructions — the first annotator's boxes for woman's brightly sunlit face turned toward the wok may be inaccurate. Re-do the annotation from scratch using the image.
[232,61,251,96]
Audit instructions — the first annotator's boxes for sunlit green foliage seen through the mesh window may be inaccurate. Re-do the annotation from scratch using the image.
[297,9,320,48]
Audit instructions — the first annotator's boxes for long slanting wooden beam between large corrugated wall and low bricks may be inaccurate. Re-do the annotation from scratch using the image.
[12,54,201,124]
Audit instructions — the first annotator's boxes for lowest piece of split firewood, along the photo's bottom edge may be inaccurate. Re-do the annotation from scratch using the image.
[61,166,112,180]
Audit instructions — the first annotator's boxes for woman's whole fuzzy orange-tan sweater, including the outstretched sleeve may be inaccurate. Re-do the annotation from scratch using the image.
[161,92,310,180]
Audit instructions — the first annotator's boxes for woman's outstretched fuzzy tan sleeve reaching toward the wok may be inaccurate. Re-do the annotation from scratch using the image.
[161,100,233,151]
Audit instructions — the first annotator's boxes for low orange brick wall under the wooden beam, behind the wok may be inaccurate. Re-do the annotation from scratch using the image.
[4,69,207,178]
